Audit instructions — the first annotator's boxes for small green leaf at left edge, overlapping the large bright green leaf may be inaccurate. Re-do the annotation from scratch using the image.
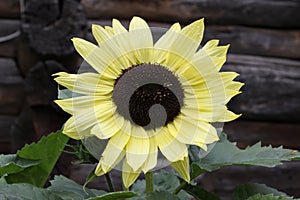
[0,154,40,177]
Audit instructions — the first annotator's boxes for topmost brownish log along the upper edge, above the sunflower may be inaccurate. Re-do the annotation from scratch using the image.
[82,0,300,28]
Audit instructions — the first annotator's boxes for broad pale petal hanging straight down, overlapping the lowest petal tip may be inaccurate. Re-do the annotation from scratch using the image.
[126,125,150,171]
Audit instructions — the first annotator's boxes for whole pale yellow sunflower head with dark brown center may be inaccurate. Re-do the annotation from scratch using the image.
[54,17,243,188]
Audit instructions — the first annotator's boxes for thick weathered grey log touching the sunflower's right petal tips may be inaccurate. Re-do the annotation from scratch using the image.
[222,55,300,122]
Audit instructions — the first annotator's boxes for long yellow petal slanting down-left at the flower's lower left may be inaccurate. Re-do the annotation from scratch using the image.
[100,131,130,173]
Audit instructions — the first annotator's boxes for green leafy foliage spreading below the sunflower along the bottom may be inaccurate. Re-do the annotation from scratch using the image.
[0,128,300,200]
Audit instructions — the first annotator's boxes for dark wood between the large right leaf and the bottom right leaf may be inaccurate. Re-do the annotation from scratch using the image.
[198,162,300,200]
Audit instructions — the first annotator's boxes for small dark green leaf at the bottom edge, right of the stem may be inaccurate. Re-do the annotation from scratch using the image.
[183,184,220,200]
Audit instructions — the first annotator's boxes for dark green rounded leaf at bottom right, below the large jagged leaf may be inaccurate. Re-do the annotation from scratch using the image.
[233,183,287,200]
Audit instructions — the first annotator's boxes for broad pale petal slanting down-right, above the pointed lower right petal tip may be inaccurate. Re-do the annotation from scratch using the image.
[155,127,187,162]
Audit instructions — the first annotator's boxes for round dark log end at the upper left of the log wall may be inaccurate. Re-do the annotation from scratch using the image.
[22,0,85,56]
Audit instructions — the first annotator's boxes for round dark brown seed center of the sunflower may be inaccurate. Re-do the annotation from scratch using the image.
[112,64,184,130]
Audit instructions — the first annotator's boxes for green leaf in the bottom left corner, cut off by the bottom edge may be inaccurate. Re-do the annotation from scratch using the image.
[0,183,63,200]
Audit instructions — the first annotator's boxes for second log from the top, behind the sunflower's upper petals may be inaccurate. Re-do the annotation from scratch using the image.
[87,20,300,59]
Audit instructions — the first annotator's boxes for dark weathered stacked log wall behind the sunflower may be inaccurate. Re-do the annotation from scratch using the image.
[0,0,300,199]
